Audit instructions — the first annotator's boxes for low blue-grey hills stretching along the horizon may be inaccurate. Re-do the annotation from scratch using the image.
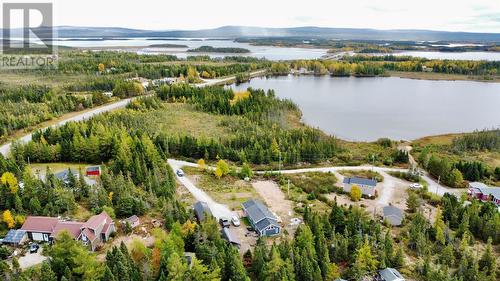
[3,26,500,42]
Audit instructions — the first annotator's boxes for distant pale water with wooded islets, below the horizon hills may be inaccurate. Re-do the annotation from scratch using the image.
[54,38,500,61]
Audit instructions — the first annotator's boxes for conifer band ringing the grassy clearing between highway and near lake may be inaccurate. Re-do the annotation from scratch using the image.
[13,85,340,164]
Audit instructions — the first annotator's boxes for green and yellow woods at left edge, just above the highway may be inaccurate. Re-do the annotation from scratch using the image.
[0,85,107,141]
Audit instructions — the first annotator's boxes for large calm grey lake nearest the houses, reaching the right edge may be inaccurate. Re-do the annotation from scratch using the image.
[232,76,500,141]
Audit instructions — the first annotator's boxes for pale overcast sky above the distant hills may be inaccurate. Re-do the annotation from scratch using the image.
[0,0,500,33]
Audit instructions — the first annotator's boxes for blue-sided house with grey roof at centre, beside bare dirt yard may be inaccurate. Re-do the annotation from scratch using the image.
[243,199,281,236]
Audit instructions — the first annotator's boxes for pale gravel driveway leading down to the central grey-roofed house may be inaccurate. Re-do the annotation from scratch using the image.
[168,159,235,220]
